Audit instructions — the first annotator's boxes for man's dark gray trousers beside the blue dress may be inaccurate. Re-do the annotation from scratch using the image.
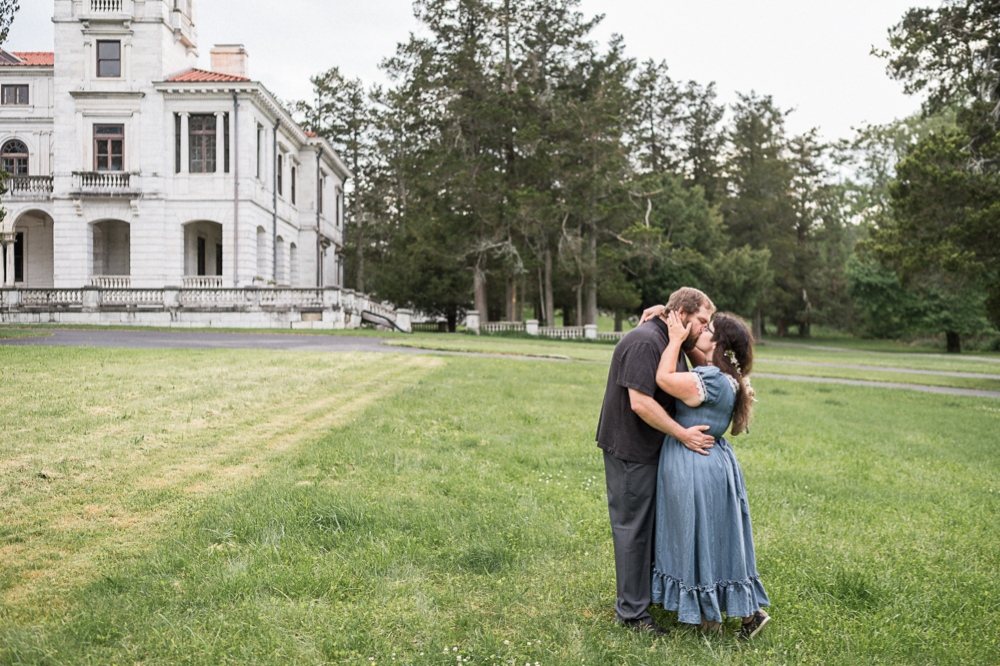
[604,452,657,623]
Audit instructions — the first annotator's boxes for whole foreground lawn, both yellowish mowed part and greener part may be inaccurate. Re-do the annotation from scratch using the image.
[0,348,1000,666]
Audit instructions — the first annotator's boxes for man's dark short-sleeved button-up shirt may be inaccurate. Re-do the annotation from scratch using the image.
[597,317,688,465]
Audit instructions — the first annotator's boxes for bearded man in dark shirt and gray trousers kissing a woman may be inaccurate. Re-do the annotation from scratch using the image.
[597,287,715,636]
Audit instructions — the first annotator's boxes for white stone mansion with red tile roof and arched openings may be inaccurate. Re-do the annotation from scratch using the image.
[0,0,351,289]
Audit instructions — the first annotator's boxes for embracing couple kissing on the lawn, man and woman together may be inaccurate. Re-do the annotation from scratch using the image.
[597,287,770,639]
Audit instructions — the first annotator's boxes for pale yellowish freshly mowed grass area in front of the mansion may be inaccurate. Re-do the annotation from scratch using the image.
[0,348,437,618]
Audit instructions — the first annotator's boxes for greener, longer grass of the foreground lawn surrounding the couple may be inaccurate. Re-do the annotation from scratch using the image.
[0,357,1000,666]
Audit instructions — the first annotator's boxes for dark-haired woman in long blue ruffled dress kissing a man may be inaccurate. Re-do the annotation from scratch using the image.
[653,312,771,639]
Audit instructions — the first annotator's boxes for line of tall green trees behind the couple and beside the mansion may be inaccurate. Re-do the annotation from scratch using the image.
[296,0,1000,348]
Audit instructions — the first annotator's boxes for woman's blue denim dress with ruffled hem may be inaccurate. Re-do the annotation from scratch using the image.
[653,366,771,624]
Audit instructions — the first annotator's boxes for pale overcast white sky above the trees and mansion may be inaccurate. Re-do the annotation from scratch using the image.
[5,0,920,139]
